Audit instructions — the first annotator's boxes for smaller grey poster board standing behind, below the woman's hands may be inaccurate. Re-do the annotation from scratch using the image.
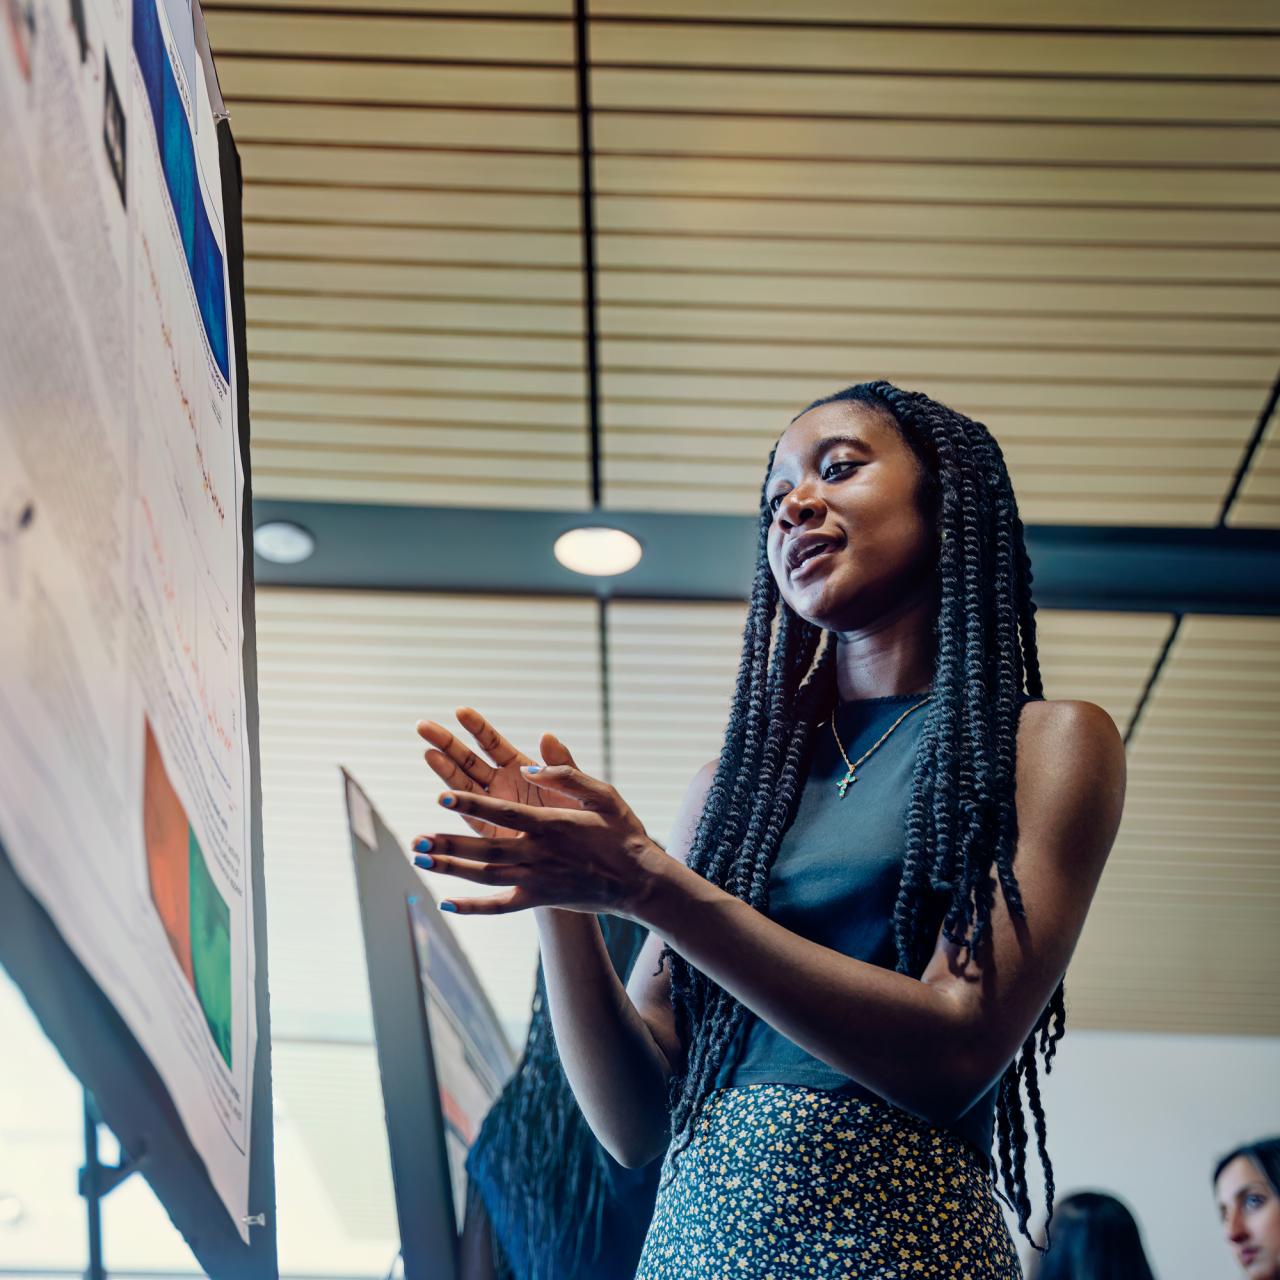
[343,771,516,1280]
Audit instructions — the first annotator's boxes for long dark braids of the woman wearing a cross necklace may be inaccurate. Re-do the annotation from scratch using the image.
[659,381,1065,1243]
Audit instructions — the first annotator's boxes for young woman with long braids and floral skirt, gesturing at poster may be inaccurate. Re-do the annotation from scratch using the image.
[416,381,1125,1280]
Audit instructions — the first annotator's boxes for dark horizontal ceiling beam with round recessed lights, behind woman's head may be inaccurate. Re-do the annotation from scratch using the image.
[253,498,1280,614]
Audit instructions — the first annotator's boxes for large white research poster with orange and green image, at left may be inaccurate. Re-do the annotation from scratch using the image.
[0,0,257,1240]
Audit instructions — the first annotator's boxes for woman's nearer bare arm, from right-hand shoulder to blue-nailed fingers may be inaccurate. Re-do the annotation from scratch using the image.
[419,703,1125,1123]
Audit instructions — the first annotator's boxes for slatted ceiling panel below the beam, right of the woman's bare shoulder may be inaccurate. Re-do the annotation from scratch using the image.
[1068,617,1280,1036]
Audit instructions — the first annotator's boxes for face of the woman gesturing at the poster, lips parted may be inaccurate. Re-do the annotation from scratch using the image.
[764,401,937,631]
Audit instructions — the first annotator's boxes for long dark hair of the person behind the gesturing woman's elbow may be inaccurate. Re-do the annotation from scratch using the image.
[467,915,645,1280]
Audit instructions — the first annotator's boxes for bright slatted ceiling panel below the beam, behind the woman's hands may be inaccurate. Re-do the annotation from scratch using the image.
[257,589,603,1042]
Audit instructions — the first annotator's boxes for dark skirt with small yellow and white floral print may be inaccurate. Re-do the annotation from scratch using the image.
[636,1084,1021,1280]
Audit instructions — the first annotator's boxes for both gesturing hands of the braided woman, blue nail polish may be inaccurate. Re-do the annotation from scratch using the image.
[413,712,668,919]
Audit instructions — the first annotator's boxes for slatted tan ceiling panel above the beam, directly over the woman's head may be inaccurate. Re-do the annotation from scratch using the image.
[591,11,1280,525]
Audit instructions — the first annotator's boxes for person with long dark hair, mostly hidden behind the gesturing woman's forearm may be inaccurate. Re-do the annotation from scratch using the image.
[460,915,660,1280]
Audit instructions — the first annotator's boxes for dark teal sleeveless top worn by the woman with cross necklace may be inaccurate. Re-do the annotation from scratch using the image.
[717,694,996,1160]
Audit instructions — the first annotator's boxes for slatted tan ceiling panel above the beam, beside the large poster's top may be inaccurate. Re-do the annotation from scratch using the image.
[206,0,590,509]
